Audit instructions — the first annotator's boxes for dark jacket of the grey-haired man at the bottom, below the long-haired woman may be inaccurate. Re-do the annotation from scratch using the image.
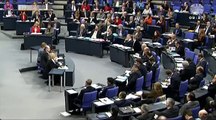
[159,106,179,118]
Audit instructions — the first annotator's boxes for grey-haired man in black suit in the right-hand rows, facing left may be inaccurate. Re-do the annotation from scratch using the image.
[179,61,193,81]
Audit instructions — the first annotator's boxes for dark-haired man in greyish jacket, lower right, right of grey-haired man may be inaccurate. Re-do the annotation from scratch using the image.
[179,92,199,115]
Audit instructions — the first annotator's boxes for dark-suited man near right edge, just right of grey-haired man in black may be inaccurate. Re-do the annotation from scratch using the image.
[188,66,204,91]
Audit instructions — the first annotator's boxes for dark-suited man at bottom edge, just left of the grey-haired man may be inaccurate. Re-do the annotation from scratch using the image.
[137,104,154,120]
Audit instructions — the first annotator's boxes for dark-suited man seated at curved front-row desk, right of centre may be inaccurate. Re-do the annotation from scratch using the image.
[127,64,142,92]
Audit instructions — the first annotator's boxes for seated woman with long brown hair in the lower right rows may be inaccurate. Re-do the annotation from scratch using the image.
[139,82,163,103]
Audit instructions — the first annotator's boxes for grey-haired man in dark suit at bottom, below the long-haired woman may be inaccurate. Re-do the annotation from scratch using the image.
[156,98,179,118]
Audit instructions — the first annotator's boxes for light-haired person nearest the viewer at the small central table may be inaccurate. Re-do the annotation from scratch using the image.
[43,53,60,78]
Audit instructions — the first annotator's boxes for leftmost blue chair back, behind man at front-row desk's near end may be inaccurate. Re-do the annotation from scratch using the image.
[82,91,97,109]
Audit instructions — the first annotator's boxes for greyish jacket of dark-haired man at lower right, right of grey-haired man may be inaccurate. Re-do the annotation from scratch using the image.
[179,101,199,115]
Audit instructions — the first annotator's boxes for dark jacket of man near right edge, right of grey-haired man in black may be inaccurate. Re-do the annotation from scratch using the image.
[188,74,204,91]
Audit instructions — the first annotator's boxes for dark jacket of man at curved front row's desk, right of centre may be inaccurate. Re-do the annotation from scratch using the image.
[127,71,142,92]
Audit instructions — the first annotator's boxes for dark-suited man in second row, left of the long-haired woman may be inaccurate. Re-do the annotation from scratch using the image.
[114,91,132,107]
